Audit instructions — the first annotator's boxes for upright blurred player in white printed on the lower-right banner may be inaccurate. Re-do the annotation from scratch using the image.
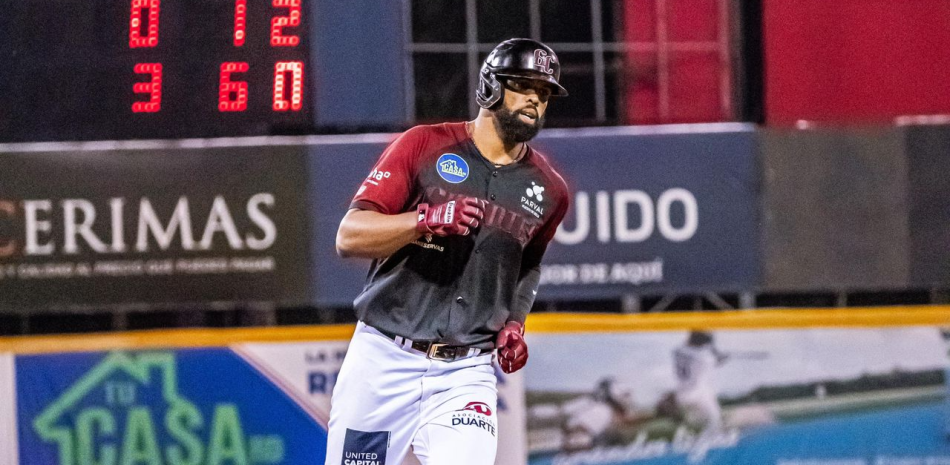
[673,331,727,430]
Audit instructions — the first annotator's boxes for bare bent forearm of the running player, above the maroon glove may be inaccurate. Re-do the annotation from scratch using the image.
[336,209,419,258]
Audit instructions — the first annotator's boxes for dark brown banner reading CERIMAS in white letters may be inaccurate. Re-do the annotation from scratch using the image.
[0,143,310,311]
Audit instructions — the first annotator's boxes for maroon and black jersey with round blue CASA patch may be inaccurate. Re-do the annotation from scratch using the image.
[350,123,569,348]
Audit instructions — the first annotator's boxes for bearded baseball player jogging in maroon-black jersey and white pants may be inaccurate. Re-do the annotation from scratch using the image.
[326,39,568,465]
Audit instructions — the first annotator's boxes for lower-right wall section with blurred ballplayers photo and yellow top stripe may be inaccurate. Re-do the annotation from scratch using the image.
[525,307,950,465]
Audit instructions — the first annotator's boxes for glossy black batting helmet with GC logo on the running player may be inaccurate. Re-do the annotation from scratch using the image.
[475,39,567,108]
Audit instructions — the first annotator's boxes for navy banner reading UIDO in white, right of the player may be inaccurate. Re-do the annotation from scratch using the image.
[538,124,760,299]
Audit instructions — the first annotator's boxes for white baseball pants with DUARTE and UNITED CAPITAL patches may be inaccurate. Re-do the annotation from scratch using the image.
[326,322,499,465]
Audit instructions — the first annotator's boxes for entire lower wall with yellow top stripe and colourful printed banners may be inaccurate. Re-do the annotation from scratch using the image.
[0,306,950,465]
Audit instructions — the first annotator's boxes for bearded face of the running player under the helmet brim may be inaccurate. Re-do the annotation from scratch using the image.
[495,79,552,143]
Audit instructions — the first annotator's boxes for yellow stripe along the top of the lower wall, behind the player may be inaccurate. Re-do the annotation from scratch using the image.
[0,305,950,354]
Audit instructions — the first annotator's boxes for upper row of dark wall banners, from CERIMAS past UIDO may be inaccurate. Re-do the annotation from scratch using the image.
[7,123,950,314]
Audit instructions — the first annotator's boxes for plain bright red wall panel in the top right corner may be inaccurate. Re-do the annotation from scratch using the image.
[763,0,950,124]
